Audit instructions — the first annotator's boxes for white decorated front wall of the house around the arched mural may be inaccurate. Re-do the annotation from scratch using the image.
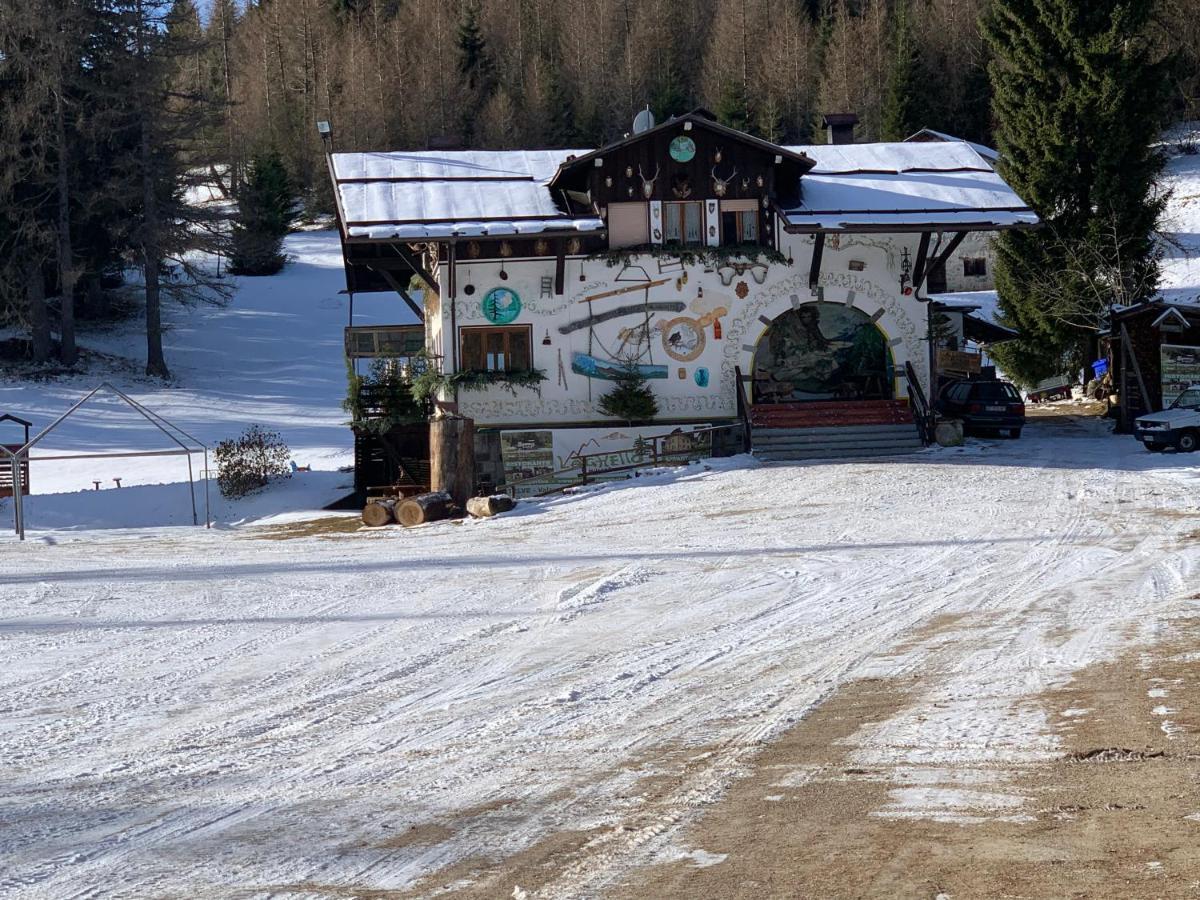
[430,222,929,426]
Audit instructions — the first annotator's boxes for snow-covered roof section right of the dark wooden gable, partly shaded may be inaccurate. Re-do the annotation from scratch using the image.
[784,142,1038,232]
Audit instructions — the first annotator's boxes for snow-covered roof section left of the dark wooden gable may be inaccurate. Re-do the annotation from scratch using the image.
[332,150,604,240]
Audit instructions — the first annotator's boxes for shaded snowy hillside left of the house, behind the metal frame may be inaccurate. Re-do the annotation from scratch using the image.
[0,232,412,529]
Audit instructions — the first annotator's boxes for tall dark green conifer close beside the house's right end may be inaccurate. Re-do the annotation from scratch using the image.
[983,0,1166,382]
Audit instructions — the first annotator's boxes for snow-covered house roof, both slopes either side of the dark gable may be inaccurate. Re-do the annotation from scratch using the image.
[332,140,1038,240]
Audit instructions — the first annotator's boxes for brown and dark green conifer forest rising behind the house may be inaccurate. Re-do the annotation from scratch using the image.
[0,0,1200,374]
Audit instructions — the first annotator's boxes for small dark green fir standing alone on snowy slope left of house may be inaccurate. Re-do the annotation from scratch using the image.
[229,152,293,275]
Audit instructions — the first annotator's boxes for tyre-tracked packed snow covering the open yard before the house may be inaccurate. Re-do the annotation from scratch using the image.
[0,419,1200,898]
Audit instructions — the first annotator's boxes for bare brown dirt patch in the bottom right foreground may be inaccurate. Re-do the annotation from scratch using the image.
[606,619,1200,900]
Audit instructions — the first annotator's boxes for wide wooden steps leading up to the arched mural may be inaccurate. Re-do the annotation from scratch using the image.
[750,400,922,462]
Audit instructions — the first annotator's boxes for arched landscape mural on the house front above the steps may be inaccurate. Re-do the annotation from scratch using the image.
[752,302,895,403]
